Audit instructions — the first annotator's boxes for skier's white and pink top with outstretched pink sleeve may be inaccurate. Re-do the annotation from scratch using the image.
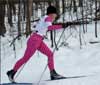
[36,15,62,36]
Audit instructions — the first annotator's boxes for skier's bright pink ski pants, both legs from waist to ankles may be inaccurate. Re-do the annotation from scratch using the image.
[13,33,54,71]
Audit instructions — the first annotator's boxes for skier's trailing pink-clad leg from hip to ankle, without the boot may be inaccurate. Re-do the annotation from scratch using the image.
[13,36,41,71]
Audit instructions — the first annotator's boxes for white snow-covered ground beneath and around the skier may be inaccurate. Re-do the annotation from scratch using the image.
[1,24,100,85]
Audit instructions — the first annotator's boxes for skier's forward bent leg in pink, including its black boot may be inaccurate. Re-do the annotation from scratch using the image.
[38,42,65,80]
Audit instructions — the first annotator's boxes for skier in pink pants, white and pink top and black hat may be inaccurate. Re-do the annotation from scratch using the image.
[7,5,67,82]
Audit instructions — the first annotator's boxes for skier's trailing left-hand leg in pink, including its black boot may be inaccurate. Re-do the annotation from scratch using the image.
[7,34,42,82]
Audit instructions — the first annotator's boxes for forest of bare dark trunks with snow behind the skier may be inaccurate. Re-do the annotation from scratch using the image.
[0,0,100,47]
